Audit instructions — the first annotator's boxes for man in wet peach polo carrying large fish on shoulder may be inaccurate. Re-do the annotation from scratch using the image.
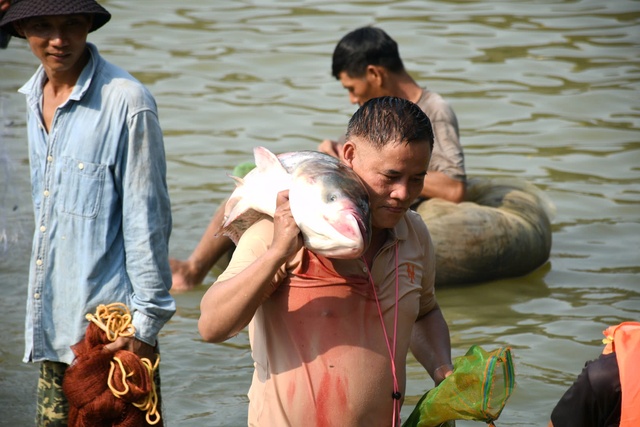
[198,97,452,427]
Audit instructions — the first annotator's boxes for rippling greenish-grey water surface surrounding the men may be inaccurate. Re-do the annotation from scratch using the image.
[0,0,640,427]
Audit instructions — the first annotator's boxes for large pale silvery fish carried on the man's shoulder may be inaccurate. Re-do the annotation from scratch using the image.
[222,147,371,259]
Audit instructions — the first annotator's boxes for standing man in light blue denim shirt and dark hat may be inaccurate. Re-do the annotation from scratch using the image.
[0,0,175,425]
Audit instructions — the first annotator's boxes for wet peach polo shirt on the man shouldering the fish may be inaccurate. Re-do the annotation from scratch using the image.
[218,212,436,427]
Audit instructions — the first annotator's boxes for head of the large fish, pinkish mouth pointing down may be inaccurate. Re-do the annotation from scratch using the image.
[289,156,371,259]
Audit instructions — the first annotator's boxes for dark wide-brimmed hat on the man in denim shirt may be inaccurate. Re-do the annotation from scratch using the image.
[0,0,111,38]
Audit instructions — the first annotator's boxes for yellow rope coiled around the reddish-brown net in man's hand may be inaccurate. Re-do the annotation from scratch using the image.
[86,302,160,425]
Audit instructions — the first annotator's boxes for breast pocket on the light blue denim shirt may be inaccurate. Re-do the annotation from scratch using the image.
[58,157,107,219]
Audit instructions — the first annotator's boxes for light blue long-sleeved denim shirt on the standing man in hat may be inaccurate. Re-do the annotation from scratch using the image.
[20,44,175,363]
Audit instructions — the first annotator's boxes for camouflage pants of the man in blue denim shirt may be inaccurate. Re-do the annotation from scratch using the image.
[36,361,164,427]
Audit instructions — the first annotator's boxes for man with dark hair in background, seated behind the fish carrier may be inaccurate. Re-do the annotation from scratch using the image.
[169,27,466,291]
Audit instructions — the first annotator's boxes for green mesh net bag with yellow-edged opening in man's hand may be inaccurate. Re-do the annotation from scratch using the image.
[402,345,515,427]
